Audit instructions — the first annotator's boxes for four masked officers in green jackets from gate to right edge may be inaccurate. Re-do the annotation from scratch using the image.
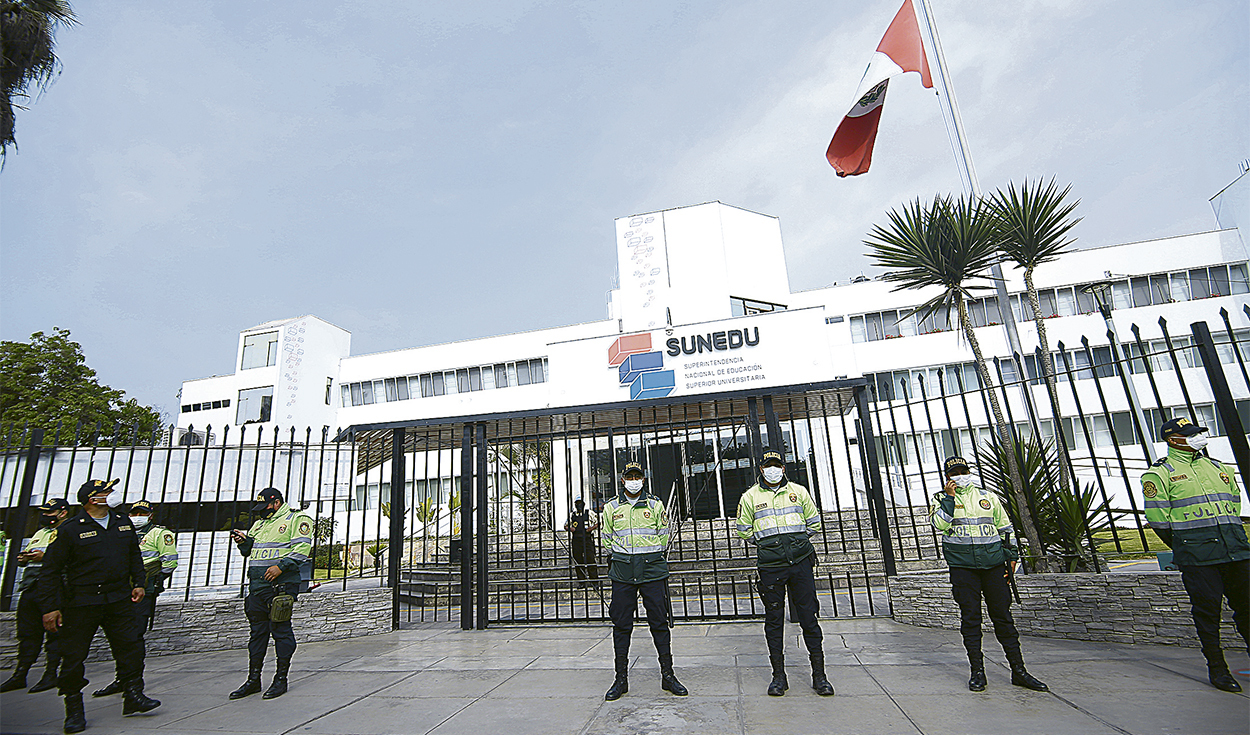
[603,419,1250,700]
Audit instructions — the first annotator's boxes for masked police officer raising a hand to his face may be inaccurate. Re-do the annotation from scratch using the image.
[929,456,1050,691]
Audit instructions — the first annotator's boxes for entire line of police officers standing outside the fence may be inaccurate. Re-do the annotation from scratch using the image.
[9,419,1250,733]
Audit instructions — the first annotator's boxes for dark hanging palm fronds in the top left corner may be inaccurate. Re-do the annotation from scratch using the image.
[0,0,78,160]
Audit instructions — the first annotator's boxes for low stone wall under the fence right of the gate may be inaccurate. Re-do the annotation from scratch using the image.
[889,570,1245,648]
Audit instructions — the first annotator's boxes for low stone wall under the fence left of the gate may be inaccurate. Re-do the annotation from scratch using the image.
[0,588,391,669]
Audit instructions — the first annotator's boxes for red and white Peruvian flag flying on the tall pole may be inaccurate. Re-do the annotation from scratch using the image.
[825,0,934,176]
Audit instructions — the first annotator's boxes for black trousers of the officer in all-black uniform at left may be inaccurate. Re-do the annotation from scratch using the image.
[56,596,144,695]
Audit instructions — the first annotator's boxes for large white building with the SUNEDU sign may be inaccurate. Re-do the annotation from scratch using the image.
[178,192,1250,525]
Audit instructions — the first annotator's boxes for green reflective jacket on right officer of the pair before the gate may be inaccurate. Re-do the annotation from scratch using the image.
[738,480,820,569]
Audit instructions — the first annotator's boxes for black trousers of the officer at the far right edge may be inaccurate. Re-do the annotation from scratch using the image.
[1180,560,1250,668]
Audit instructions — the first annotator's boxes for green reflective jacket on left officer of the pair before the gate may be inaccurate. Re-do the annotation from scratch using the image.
[603,494,669,585]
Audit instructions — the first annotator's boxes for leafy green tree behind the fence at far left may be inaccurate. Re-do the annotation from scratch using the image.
[0,326,164,444]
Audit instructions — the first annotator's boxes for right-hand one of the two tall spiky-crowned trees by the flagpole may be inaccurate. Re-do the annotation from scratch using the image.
[990,179,1081,493]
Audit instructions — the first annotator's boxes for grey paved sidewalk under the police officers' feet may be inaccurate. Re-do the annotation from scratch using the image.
[0,619,1250,735]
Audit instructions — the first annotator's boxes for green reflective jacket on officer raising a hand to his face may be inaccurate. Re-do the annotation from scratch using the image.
[929,485,1020,569]
